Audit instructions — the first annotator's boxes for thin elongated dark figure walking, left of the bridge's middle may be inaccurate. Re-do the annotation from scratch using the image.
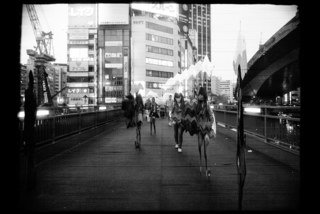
[135,92,144,148]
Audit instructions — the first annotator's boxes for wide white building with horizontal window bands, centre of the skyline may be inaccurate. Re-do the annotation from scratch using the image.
[131,4,180,96]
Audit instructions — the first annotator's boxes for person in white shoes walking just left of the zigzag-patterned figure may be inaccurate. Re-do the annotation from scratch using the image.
[172,93,185,153]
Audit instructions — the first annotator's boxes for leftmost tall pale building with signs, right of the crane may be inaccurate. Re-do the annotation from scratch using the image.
[67,4,98,106]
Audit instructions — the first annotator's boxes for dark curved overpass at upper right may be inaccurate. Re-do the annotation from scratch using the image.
[243,13,300,100]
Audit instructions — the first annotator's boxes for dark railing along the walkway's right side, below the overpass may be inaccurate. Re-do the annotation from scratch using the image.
[212,105,300,155]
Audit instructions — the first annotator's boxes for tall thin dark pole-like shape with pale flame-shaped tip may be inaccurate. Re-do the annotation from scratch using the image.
[233,23,247,210]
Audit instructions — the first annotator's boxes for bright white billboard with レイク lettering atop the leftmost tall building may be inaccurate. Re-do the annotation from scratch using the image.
[68,4,97,27]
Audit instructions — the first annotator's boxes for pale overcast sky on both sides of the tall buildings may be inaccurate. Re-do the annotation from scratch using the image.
[20,4,298,80]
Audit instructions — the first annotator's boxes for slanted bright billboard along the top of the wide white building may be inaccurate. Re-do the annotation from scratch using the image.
[131,3,179,18]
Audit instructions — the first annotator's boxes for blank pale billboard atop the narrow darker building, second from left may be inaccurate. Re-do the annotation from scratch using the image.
[98,4,129,25]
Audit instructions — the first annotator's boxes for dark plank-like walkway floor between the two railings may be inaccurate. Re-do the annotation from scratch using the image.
[20,115,300,212]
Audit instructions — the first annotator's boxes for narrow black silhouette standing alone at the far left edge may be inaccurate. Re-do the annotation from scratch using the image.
[23,71,37,189]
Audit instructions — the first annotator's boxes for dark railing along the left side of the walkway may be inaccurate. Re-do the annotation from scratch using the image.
[19,108,123,148]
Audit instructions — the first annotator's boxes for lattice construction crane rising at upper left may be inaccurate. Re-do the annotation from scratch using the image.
[26,4,55,106]
